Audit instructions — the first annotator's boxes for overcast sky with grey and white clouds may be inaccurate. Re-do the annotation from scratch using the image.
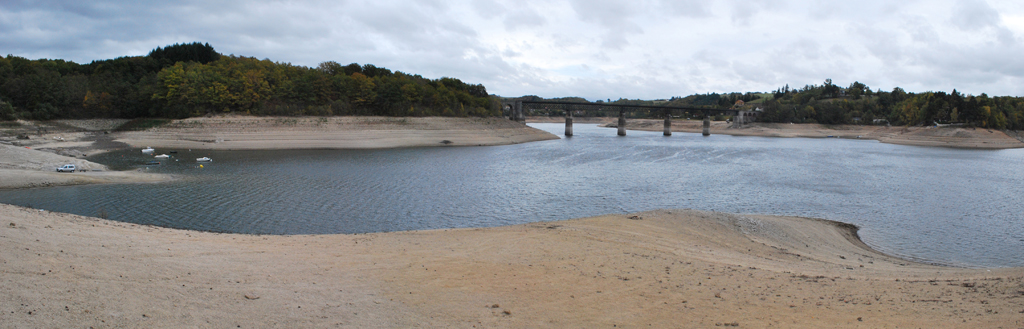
[0,0,1024,100]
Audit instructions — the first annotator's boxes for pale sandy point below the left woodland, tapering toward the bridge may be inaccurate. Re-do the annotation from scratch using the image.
[116,116,558,150]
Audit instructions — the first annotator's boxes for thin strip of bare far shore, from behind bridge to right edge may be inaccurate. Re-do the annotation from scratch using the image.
[527,117,1024,150]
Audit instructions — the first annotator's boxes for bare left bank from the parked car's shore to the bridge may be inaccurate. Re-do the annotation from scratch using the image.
[0,116,558,189]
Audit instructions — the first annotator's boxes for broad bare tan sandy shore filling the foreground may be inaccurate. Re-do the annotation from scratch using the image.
[0,205,1024,328]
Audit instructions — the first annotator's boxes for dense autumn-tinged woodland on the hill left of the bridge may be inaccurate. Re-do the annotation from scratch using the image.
[0,43,501,120]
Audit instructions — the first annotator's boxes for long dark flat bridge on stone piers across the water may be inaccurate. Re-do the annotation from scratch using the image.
[502,100,745,136]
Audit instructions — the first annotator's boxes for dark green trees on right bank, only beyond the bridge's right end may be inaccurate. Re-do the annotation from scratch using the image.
[752,80,1024,130]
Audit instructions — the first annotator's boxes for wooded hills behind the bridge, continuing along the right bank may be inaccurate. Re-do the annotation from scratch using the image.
[519,79,1024,130]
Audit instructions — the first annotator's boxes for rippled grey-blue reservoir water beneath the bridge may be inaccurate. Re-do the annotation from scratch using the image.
[0,124,1024,266]
